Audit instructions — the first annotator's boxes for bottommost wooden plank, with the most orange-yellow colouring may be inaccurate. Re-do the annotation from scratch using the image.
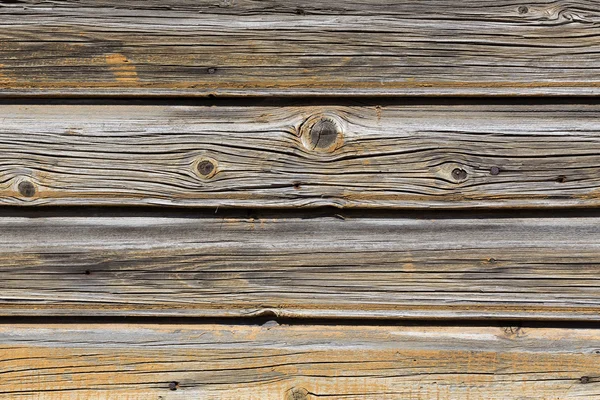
[0,324,600,400]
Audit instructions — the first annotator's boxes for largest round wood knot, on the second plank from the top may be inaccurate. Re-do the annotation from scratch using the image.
[300,116,343,152]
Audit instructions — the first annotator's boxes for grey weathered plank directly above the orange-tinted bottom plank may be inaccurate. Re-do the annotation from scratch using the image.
[0,213,600,320]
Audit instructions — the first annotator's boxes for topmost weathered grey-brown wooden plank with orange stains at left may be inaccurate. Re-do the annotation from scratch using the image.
[0,0,600,96]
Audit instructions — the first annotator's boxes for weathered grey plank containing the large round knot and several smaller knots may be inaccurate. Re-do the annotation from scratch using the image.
[0,104,600,209]
